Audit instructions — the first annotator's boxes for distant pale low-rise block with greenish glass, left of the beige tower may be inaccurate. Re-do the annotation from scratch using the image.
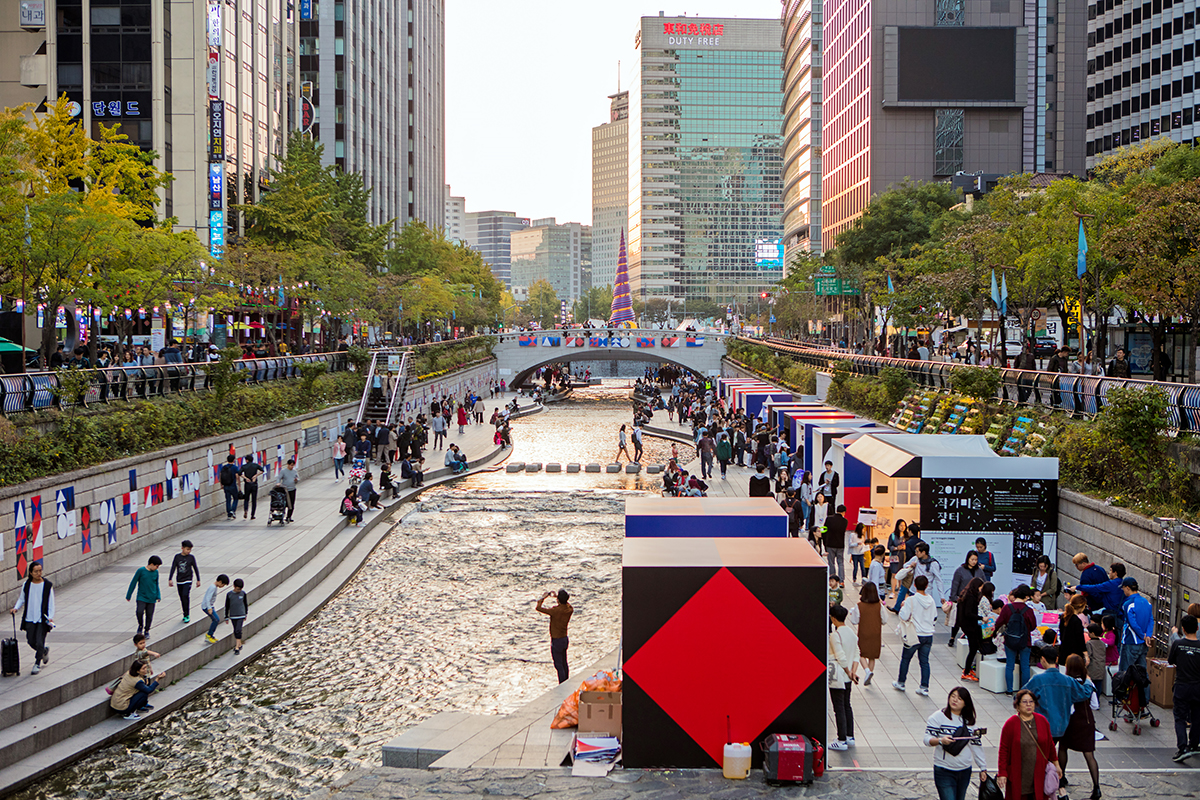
[511,217,592,303]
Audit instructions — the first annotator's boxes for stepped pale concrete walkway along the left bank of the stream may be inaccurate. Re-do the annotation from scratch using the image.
[0,401,541,795]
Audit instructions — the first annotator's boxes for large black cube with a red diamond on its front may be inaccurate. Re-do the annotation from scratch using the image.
[622,537,829,769]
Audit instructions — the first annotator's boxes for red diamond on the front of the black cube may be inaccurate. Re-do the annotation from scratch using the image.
[625,569,826,765]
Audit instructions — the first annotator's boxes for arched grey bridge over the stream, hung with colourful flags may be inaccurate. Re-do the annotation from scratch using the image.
[492,327,726,386]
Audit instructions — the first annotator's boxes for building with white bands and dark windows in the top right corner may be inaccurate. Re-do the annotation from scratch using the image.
[1086,0,1200,168]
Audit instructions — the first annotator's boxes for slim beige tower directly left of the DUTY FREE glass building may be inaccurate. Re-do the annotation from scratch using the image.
[592,91,629,287]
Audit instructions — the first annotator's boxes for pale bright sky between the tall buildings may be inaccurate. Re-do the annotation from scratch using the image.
[445,0,780,223]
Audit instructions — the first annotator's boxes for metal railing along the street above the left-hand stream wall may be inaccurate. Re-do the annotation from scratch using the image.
[0,353,348,416]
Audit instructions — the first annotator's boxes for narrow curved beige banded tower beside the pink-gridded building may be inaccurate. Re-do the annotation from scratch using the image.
[781,0,822,265]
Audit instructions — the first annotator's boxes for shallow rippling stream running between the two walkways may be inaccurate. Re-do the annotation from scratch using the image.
[17,379,692,800]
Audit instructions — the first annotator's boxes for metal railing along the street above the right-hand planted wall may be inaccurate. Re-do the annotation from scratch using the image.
[743,338,1200,432]
